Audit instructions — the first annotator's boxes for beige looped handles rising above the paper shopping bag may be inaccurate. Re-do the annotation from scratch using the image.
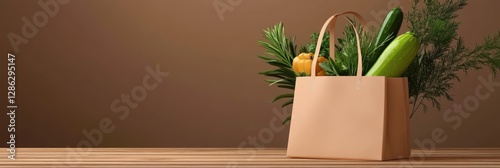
[311,11,366,77]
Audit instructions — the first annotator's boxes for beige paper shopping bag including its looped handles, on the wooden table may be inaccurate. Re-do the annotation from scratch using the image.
[287,12,410,160]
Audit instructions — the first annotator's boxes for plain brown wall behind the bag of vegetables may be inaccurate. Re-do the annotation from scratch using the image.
[0,0,500,147]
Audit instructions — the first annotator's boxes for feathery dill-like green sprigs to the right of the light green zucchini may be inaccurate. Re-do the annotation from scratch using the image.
[403,0,500,116]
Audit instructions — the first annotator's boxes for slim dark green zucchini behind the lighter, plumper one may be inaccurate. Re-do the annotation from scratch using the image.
[374,7,404,58]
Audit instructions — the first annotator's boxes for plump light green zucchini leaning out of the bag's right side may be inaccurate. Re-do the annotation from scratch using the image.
[366,32,420,77]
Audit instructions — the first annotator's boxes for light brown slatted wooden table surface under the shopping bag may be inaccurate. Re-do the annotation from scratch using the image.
[0,148,500,168]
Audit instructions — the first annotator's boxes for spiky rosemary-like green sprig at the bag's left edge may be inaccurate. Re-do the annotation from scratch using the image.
[258,23,297,124]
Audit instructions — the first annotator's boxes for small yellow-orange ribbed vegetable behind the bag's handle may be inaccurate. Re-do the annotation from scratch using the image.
[292,53,326,76]
